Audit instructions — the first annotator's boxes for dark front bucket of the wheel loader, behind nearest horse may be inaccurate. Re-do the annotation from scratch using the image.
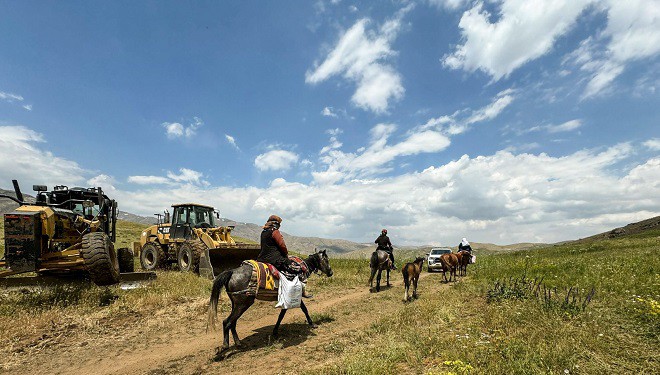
[199,244,261,279]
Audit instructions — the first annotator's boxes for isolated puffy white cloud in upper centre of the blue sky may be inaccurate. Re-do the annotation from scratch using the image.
[305,4,413,113]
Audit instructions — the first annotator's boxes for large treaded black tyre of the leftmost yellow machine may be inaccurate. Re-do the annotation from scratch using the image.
[80,232,119,286]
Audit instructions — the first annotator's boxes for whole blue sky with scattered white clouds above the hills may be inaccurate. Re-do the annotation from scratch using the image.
[0,0,660,246]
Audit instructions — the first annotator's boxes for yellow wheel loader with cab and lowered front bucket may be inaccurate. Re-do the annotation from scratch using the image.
[133,203,261,278]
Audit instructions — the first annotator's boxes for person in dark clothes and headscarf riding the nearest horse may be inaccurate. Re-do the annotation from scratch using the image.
[257,215,312,298]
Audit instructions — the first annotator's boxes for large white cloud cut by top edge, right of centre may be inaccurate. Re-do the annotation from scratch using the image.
[442,0,594,81]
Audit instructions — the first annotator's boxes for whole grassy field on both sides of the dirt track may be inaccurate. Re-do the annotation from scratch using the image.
[0,223,660,374]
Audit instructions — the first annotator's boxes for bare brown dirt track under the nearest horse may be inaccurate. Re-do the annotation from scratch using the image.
[3,273,446,374]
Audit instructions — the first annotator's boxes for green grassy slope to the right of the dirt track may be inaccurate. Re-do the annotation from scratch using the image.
[310,231,660,374]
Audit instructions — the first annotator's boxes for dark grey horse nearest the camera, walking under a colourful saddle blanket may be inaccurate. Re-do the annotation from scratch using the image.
[209,250,332,357]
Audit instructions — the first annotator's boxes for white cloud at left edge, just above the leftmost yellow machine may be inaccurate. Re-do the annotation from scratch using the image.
[0,126,89,189]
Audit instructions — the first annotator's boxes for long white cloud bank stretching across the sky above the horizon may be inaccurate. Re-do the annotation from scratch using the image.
[0,124,660,246]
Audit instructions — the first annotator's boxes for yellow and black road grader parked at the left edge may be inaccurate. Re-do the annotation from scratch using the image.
[0,180,134,286]
